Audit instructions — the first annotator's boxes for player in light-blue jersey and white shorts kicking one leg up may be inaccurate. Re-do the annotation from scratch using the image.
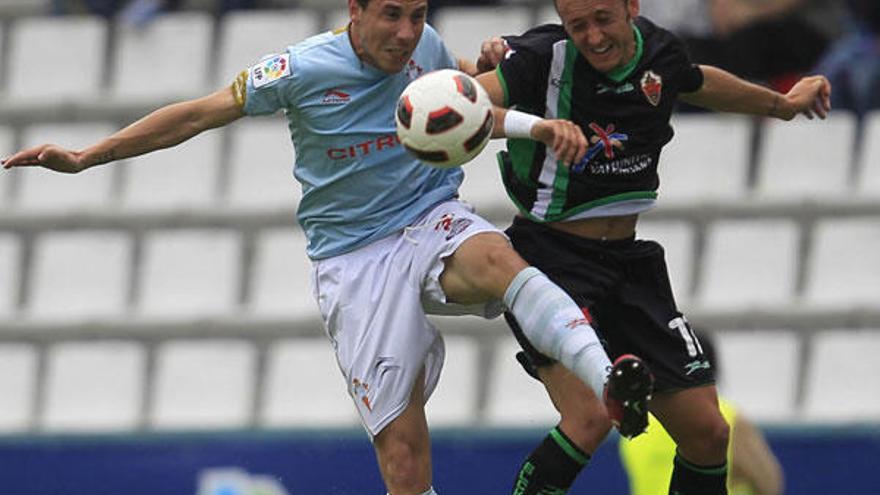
[3,0,650,495]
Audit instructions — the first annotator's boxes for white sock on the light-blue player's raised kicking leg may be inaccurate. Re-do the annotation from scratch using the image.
[504,266,611,399]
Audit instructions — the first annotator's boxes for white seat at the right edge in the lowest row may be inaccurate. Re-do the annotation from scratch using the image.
[803,328,880,422]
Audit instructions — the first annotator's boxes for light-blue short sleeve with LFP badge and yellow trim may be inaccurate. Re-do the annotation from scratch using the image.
[232,52,295,115]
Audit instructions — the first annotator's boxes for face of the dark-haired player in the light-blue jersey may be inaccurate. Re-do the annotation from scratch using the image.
[348,0,428,74]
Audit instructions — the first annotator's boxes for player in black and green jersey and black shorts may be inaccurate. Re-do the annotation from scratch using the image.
[478,0,831,495]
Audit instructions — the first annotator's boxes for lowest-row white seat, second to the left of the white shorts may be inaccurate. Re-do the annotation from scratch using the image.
[150,340,256,429]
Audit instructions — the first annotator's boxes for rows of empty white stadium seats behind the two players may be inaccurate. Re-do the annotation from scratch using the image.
[0,8,880,432]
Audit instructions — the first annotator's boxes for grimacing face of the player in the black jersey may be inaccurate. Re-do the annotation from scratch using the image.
[556,0,639,72]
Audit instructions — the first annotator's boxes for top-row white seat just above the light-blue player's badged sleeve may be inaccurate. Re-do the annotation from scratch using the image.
[214,9,318,88]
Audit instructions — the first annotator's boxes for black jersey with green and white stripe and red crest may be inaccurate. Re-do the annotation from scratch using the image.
[497,17,703,222]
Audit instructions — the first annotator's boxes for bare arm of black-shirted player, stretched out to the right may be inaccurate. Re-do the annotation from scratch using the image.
[680,65,831,120]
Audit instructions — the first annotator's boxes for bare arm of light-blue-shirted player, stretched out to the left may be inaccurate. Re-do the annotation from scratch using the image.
[2,88,242,174]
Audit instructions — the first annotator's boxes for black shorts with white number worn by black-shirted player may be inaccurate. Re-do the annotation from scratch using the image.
[506,218,715,392]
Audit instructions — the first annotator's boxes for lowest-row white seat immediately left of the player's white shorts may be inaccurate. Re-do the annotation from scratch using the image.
[260,338,358,428]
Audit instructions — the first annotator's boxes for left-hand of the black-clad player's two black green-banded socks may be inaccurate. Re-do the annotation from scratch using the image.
[513,427,590,495]
